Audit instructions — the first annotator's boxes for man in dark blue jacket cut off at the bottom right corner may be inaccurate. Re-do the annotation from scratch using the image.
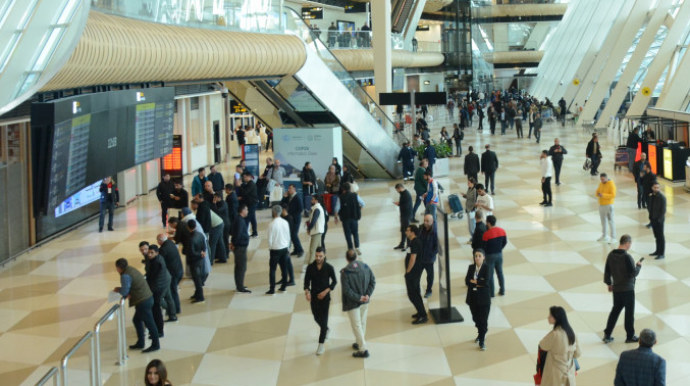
[613,328,666,386]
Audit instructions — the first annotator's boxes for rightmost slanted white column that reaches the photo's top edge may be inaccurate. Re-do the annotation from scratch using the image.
[590,0,672,128]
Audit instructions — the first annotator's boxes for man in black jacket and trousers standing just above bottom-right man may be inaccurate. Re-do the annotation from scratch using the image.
[603,235,642,343]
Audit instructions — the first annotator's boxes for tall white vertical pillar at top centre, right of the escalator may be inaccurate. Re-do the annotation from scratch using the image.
[370,0,393,123]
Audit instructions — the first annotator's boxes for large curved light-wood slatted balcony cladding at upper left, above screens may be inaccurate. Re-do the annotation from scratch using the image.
[41,11,306,91]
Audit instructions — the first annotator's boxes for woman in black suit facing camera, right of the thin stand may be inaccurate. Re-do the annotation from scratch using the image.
[465,249,491,351]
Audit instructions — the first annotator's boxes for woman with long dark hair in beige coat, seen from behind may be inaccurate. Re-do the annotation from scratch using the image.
[539,306,580,386]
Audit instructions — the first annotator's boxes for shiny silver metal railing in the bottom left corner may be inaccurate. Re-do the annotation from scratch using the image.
[36,298,128,386]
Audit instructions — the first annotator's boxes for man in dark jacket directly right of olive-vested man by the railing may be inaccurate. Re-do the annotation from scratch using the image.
[146,244,177,338]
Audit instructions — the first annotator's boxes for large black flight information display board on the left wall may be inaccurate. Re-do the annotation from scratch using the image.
[31,87,175,217]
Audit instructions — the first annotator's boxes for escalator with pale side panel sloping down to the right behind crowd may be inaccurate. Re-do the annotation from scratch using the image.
[225,9,406,179]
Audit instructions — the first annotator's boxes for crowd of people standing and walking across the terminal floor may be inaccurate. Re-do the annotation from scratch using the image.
[105,89,666,385]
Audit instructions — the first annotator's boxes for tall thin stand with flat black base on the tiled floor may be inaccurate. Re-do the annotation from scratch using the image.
[429,208,465,324]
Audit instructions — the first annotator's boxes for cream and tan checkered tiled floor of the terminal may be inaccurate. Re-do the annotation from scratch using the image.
[0,111,690,386]
